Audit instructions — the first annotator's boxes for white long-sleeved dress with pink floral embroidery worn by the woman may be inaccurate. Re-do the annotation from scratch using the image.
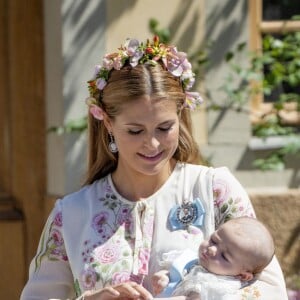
[21,163,286,300]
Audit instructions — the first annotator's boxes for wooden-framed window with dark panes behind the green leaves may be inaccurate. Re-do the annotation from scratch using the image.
[248,0,300,125]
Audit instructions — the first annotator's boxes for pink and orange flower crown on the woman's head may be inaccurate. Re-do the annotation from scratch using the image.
[86,36,203,120]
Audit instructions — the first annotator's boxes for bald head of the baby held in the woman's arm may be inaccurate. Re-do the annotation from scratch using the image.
[199,217,274,281]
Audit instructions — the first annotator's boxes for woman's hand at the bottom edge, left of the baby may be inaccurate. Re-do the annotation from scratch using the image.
[83,282,153,300]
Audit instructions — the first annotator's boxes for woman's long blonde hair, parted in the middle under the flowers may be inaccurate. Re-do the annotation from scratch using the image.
[85,63,202,184]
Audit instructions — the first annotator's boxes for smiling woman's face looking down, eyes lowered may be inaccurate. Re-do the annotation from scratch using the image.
[106,97,179,175]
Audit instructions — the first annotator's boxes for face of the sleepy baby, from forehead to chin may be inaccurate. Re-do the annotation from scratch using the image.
[199,223,247,276]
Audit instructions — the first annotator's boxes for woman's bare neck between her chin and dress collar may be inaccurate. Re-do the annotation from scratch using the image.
[112,160,176,201]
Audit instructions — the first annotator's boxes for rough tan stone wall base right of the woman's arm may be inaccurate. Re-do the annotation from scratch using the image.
[249,189,300,275]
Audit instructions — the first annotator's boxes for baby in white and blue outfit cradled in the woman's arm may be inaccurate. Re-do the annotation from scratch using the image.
[152,217,274,300]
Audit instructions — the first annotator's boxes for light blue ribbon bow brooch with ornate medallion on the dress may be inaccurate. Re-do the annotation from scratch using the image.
[168,198,205,230]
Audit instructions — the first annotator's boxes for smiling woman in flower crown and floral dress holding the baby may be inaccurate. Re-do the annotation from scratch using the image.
[21,37,286,300]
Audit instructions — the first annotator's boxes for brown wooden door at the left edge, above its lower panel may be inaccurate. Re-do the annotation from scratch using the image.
[0,0,46,280]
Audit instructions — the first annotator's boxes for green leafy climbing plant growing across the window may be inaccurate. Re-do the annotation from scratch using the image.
[222,32,300,170]
